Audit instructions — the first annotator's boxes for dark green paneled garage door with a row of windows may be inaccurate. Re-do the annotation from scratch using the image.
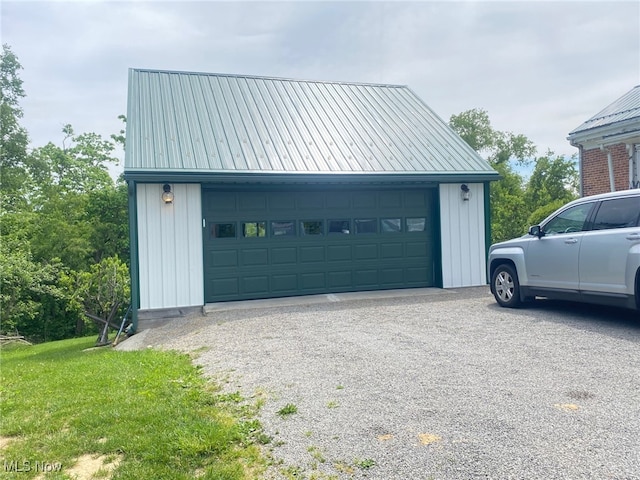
[203,188,436,303]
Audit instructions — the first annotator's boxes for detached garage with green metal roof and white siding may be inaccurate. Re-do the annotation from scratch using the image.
[125,69,498,327]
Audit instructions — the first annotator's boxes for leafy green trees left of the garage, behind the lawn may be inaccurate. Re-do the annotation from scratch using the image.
[0,45,129,341]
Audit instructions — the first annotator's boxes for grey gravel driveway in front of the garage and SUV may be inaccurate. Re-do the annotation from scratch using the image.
[122,287,640,480]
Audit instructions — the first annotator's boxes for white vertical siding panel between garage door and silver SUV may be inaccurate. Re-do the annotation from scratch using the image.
[440,183,486,288]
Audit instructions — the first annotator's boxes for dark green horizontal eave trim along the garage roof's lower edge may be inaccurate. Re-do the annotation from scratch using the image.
[124,170,500,185]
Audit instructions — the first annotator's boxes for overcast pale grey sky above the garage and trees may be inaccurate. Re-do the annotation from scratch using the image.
[0,0,640,172]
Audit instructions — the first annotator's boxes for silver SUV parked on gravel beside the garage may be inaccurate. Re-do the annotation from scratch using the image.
[487,190,640,309]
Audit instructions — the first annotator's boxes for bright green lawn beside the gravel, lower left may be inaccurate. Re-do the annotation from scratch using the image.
[0,337,267,480]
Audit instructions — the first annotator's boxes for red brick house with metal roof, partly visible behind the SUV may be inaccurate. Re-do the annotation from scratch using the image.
[567,85,640,196]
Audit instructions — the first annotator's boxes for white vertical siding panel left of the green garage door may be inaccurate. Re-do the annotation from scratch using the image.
[137,184,204,310]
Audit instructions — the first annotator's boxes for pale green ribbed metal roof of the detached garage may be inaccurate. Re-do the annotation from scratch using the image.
[125,69,498,182]
